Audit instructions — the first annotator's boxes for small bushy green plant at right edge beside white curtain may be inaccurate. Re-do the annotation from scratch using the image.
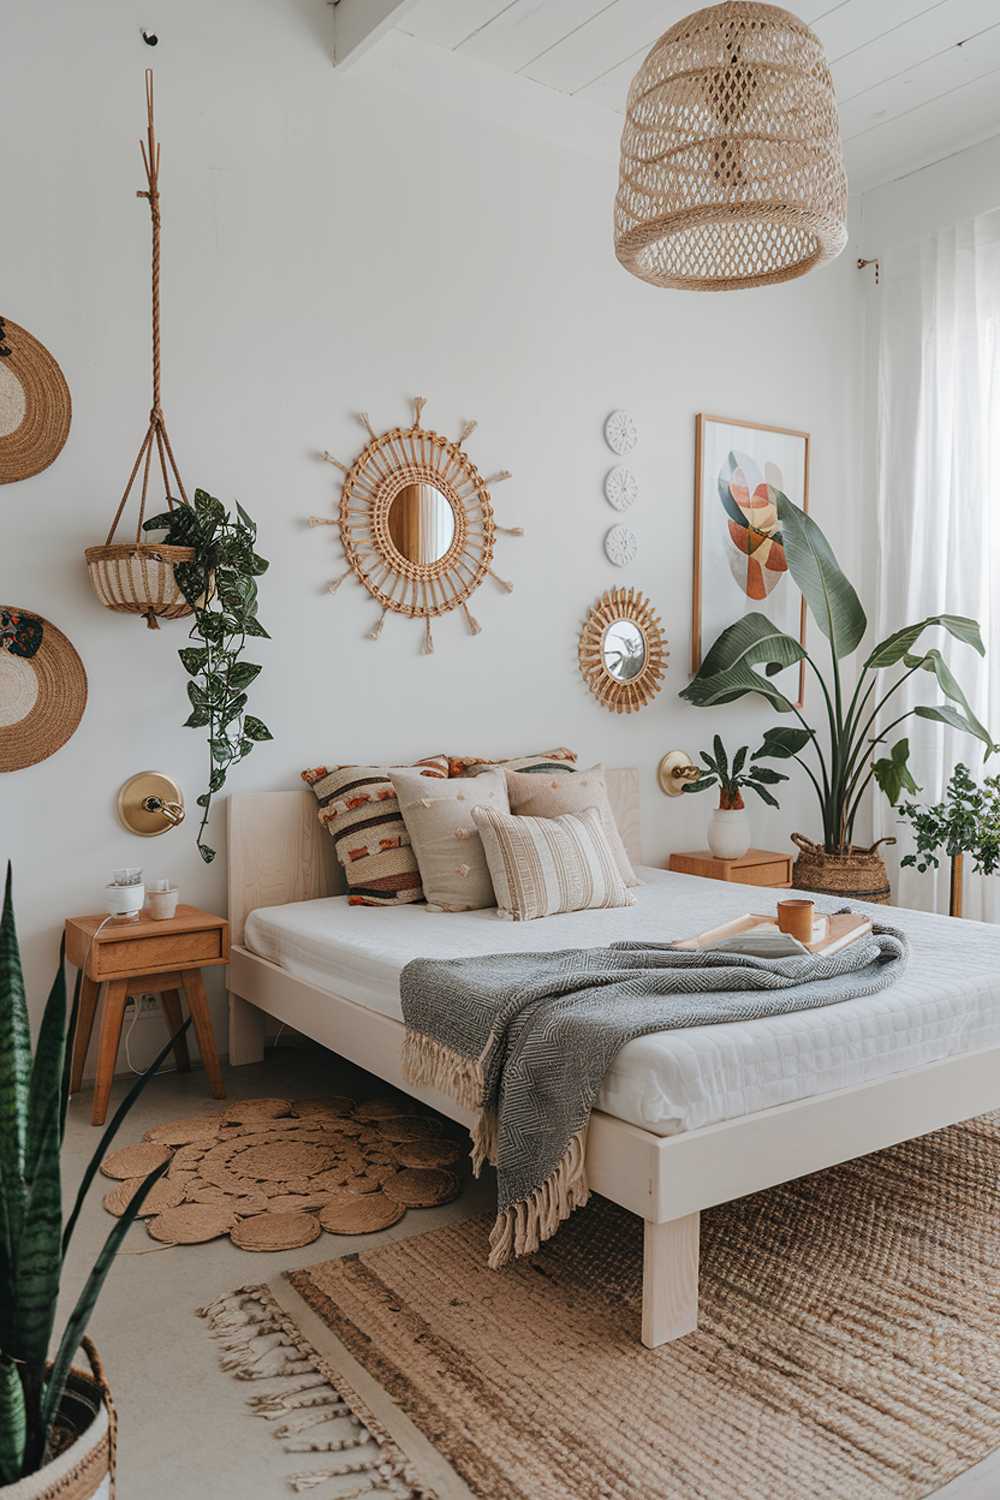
[897,764,1000,917]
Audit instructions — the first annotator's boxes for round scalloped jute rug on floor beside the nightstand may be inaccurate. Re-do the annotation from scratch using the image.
[100,1095,463,1251]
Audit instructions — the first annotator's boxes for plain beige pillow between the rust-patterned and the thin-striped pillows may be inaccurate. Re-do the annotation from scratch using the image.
[390,770,510,912]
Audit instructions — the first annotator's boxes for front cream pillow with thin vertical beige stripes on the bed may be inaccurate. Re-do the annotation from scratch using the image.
[472,804,636,923]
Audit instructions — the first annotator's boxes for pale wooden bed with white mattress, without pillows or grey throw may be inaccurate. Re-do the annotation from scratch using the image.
[229,771,1000,1347]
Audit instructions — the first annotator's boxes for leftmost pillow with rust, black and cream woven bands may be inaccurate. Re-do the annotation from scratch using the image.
[301,755,448,906]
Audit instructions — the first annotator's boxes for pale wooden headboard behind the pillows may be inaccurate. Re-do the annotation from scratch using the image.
[228,767,640,944]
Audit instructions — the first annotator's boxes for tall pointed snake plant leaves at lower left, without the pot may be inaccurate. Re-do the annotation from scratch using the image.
[0,864,189,1487]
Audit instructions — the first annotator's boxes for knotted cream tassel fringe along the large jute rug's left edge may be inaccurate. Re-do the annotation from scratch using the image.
[198,1287,433,1500]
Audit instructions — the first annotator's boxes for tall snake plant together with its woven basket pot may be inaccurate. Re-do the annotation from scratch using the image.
[0,866,189,1500]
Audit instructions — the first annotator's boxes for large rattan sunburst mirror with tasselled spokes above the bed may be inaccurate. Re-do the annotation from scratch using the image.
[309,396,523,653]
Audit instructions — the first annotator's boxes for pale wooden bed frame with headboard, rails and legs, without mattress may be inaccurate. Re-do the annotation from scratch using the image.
[228,770,1000,1349]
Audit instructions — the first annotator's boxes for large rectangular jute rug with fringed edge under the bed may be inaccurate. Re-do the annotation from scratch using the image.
[202,1116,1000,1500]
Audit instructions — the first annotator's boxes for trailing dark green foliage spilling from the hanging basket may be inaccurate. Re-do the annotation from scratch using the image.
[144,489,271,864]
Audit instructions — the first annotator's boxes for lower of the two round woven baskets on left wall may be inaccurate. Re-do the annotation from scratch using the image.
[0,605,87,771]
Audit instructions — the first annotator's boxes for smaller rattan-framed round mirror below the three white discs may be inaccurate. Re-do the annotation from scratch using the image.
[580,588,670,714]
